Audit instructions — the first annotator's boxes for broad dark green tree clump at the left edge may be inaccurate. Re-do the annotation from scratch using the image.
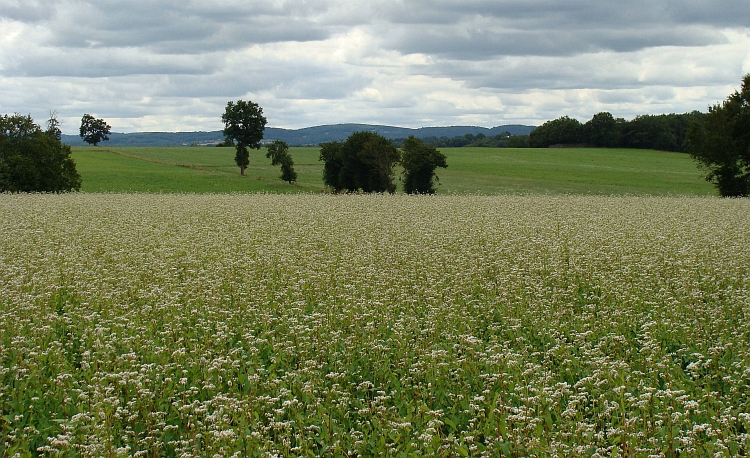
[0,114,81,192]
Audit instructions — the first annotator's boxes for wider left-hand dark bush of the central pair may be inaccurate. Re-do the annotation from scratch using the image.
[319,132,400,193]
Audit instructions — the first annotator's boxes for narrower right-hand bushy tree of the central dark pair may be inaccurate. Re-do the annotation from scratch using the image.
[401,135,448,194]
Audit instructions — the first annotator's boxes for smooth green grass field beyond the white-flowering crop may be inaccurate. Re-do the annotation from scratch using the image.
[73,147,716,196]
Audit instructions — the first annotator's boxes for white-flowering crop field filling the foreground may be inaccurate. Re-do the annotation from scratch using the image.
[0,194,750,457]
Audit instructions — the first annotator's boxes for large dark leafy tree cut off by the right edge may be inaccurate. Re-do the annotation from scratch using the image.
[688,74,750,197]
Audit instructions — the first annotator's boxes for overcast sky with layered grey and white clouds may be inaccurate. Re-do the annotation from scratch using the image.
[0,0,750,134]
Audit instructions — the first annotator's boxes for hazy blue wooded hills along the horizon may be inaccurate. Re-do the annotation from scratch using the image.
[62,124,535,146]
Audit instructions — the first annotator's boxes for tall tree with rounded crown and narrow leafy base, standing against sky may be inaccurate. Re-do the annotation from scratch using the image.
[221,100,268,176]
